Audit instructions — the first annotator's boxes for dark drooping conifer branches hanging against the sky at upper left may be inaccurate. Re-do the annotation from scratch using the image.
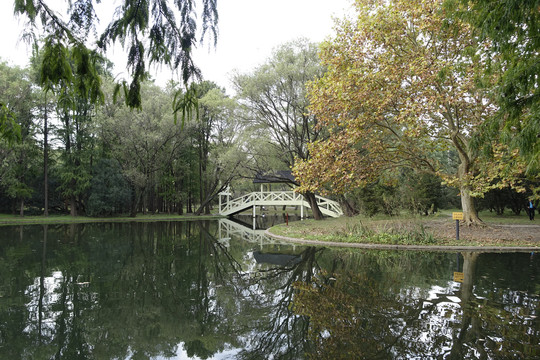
[15,0,218,108]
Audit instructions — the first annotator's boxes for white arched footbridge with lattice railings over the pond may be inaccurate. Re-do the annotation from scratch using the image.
[219,189,343,218]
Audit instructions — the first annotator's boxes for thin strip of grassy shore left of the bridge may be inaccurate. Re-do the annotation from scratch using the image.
[0,214,222,225]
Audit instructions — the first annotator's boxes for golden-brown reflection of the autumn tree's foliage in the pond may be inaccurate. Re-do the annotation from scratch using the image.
[293,262,454,359]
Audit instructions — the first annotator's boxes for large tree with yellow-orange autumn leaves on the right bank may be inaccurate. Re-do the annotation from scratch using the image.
[295,0,504,224]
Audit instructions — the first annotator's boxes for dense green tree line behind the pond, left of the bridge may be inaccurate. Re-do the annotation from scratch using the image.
[0,59,244,216]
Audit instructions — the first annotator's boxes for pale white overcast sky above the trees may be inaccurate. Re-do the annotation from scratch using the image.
[0,0,352,94]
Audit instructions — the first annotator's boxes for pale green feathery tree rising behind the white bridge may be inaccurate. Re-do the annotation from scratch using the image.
[234,39,324,219]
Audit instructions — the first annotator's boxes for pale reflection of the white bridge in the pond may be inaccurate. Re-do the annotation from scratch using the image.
[218,219,295,248]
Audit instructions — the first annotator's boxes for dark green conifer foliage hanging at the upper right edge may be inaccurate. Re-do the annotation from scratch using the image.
[450,0,540,176]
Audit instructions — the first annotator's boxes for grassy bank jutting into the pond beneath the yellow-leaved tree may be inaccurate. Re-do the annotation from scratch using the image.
[270,211,540,247]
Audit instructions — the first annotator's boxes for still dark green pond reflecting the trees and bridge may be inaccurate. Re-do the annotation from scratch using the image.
[0,220,540,360]
